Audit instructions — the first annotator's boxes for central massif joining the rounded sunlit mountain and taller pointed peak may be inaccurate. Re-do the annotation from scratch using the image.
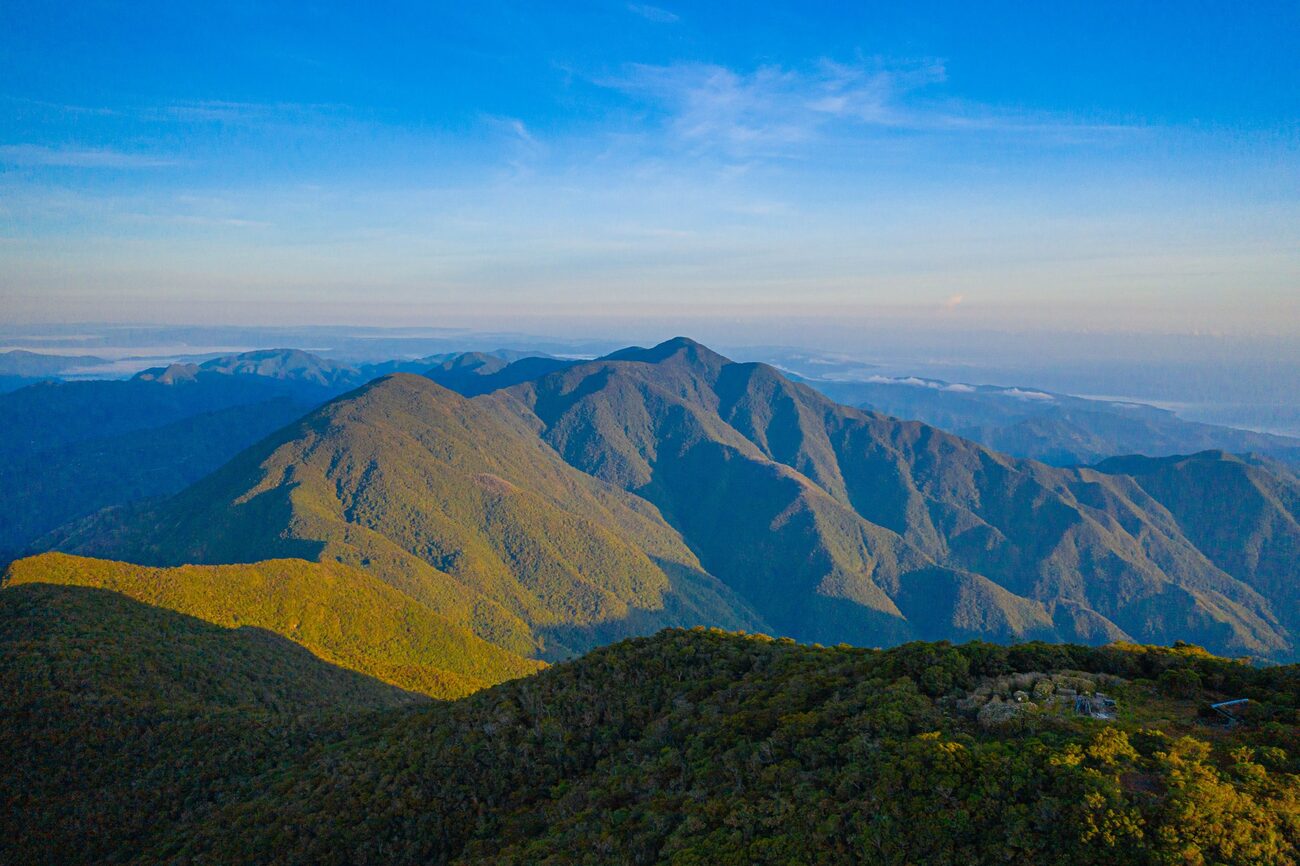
[27,339,1300,661]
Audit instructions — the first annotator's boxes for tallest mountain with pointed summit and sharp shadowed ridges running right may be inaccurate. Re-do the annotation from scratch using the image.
[506,338,1300,658]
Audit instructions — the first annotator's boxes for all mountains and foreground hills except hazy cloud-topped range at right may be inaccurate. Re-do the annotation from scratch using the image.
[0,338,1300,866]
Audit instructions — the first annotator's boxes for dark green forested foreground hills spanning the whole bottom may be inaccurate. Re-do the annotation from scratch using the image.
[0,611,1300,866]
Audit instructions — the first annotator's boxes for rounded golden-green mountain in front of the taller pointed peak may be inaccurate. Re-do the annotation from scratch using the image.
[48,374,762,658]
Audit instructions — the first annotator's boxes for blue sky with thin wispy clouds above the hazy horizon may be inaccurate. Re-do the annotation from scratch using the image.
[0,1,1300,337]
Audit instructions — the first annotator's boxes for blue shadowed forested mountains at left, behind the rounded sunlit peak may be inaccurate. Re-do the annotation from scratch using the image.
[0,348,571,567]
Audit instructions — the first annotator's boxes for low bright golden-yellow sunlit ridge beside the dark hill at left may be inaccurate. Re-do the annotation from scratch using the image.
[4,554,538,698]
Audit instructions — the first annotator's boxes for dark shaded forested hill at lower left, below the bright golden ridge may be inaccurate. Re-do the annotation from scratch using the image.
[0,584,417,863]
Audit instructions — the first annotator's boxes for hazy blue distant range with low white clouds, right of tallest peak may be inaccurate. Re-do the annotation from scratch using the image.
[802,374,1300,466]
